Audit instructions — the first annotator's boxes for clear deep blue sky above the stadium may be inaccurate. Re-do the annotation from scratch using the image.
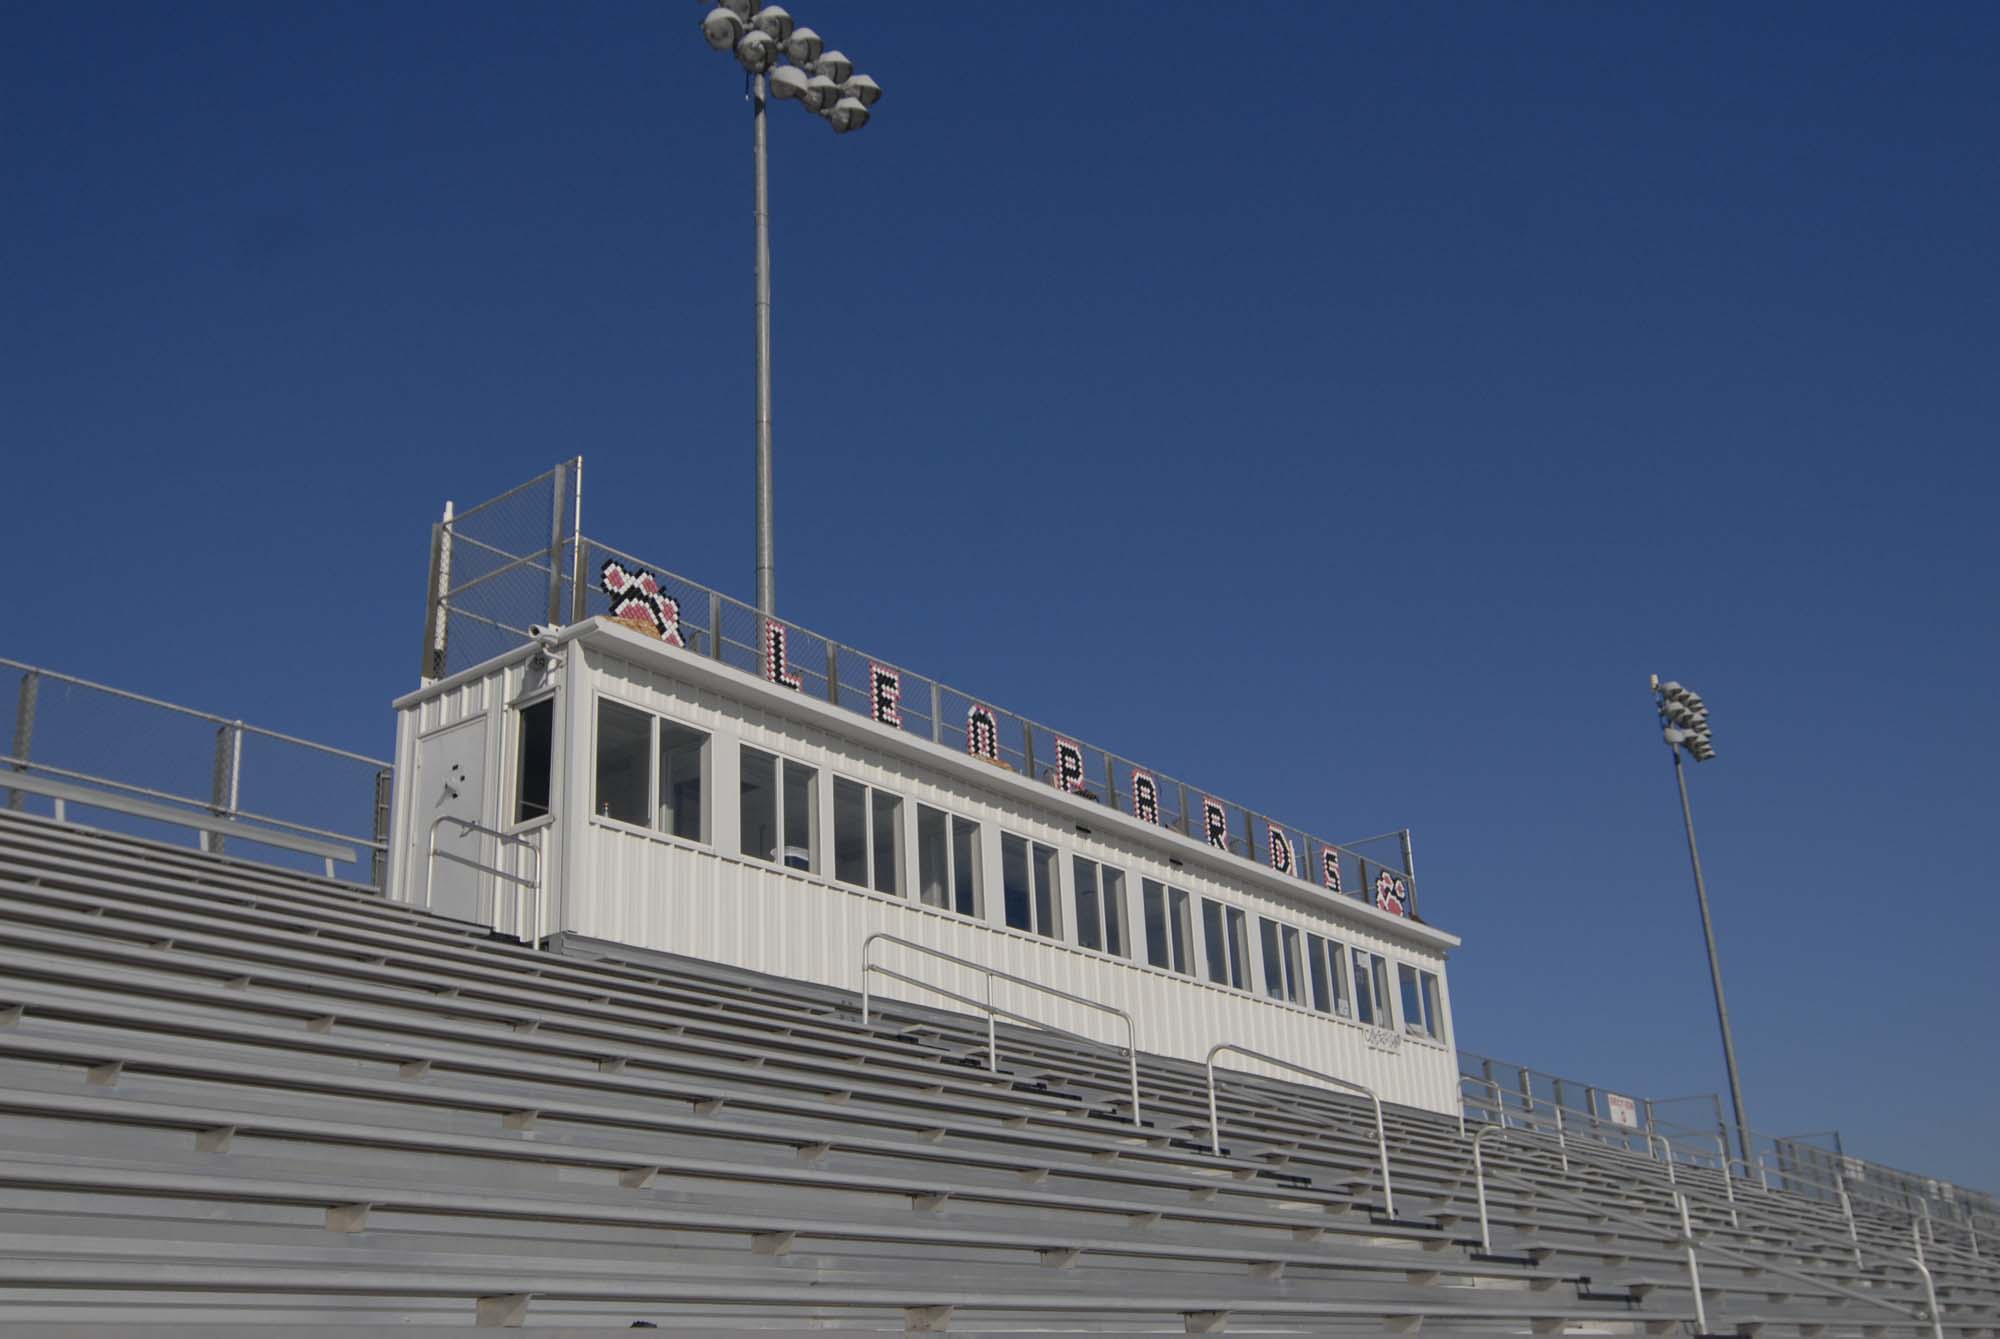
[0,0,2000,1189]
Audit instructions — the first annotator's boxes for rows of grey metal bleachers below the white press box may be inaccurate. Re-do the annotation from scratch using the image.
[0,813,2000,1339]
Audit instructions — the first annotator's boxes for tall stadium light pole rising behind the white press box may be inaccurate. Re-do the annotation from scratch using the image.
[702,0,882,618]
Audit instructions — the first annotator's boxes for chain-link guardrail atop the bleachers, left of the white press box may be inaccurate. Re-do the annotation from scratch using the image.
[0,658,392,887]
